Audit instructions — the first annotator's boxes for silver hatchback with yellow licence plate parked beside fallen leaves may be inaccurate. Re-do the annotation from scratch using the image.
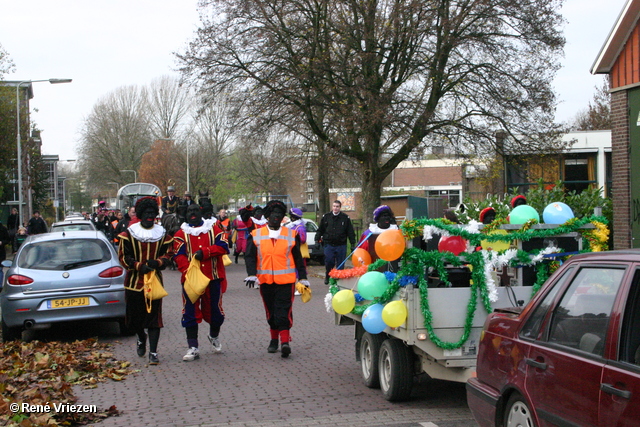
[0,231,129,342]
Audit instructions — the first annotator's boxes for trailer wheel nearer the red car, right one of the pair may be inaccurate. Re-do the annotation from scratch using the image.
[379,338,413,402]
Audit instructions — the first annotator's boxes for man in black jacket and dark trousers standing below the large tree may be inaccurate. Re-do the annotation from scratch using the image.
[316,200,356,285]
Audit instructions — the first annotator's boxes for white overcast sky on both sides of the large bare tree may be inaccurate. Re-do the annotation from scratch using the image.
[0,0,626,160]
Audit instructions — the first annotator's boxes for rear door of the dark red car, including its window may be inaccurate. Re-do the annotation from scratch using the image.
[525,266,625,426]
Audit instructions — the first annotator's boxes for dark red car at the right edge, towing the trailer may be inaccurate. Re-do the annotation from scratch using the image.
[467,249,640,427]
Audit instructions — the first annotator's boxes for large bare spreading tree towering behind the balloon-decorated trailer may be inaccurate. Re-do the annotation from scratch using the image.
[178,0,564,217]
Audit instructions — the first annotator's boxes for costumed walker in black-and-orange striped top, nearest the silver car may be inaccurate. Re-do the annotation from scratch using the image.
[118,197,173,365]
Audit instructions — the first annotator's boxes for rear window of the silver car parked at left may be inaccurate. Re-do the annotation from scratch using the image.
[18,239,111,270]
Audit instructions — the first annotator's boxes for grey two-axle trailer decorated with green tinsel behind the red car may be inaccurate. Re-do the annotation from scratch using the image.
[330,218,600,401]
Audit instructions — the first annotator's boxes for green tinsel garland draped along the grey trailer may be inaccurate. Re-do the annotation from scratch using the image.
[329,216,607,350]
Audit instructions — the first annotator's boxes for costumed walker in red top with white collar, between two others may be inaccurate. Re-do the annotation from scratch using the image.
[173,204,229,362]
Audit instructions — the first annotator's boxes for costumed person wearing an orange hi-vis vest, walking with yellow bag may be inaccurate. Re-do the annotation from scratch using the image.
[245,200,309,357]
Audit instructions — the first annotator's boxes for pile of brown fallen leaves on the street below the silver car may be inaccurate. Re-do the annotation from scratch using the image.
[0,338,134,427]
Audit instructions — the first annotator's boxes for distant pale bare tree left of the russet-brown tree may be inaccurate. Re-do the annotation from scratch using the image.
[78,86,152,197]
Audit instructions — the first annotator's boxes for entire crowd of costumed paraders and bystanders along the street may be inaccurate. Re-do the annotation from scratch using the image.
[0,183,526,365]
